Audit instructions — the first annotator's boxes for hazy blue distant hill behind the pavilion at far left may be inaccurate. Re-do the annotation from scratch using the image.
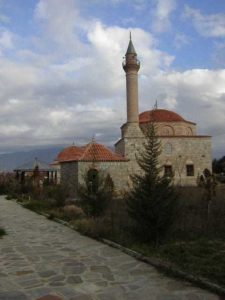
[0,146,64,171]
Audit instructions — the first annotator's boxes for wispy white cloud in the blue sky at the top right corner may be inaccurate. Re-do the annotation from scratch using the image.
[184,5,225,38]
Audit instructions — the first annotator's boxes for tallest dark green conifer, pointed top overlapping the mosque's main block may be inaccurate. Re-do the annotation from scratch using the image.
[127,123,177,245]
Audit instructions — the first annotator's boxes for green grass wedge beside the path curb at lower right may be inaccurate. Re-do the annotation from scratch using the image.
[127,239,225,288]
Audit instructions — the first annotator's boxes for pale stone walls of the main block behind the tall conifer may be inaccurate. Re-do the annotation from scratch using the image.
[116,136,212,186]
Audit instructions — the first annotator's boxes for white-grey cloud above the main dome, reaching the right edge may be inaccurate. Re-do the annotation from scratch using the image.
[146,69,225,135]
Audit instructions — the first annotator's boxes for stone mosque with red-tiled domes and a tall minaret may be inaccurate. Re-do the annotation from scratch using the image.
[54,38,212,195]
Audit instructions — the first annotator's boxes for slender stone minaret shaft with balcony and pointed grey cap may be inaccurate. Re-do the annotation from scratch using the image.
[123,33,140,123]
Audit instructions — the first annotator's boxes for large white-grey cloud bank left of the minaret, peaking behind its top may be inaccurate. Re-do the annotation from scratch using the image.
[0,12,173,149]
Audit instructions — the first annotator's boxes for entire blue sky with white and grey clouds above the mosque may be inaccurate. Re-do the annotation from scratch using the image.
[0,0,225,157]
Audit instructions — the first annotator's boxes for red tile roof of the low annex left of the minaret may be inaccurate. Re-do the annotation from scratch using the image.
[55,142,126,162]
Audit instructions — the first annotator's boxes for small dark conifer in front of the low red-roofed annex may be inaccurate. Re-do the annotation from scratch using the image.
[78,169,114,219]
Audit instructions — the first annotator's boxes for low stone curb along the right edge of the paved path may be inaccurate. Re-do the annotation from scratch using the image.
[16,201,225,296]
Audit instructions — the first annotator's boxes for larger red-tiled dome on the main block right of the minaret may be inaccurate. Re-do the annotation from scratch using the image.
[139,109,195,124]
